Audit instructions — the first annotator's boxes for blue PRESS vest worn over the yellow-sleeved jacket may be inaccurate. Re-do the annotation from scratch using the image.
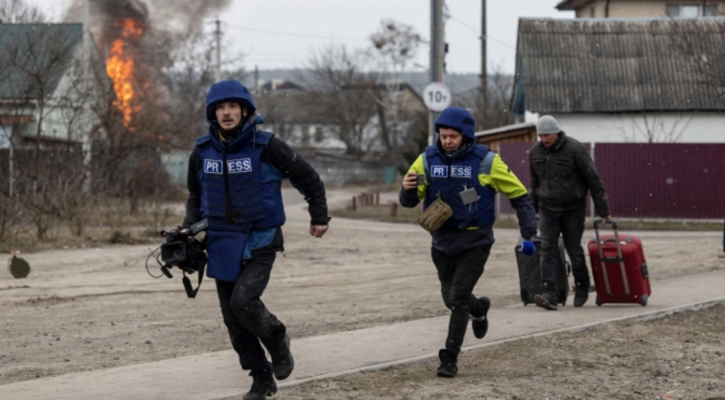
[423,144,496,229]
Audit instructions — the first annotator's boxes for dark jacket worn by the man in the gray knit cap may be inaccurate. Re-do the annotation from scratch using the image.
[529,132,609,217]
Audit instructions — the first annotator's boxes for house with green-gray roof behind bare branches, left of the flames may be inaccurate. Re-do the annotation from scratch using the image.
[0,23,112,149]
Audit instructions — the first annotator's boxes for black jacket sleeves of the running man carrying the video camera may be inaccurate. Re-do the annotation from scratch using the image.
[182,137,330,228]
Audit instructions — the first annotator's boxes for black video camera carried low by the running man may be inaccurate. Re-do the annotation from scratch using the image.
[160,219,209,278]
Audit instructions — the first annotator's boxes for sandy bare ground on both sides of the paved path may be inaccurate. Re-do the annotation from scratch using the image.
[0,190,725,400]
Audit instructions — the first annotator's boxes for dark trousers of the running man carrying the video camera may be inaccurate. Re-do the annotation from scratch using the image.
[216,247,285,376]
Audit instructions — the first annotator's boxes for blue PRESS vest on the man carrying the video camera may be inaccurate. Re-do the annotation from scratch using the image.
[196,127,285,232]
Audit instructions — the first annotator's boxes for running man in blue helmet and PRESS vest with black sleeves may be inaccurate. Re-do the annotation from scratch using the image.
[182,80,330,400]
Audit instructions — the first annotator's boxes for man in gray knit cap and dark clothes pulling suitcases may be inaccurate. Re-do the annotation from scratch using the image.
[529,115,611,310]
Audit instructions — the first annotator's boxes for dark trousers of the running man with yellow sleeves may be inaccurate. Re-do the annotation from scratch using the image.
[431,247,491,354]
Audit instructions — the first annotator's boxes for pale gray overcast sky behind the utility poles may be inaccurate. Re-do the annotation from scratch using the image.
[26,0,573,73]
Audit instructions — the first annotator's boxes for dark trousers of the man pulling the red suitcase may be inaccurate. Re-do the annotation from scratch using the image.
[539,208,590,291]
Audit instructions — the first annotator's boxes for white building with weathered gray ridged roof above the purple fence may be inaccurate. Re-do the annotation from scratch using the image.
[511,18,725,143]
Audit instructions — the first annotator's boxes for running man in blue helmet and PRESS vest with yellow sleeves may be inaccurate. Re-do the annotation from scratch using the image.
[399,107,536,378]
